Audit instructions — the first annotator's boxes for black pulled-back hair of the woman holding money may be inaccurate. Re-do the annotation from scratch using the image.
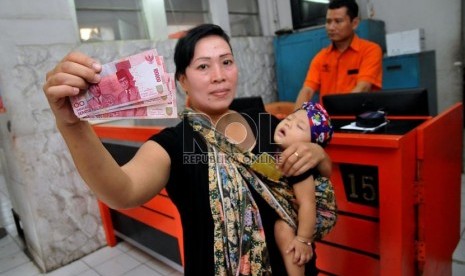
[174,24,232,80]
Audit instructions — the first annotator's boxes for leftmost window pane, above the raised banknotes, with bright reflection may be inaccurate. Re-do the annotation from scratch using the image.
[74,0,148,42]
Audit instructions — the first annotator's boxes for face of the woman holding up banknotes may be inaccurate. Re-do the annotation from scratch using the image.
[179,35,238,116]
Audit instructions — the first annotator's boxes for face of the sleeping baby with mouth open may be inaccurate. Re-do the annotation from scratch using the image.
[274,109,311,149]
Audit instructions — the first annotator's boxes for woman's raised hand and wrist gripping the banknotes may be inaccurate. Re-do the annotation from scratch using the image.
[43,52,102,125]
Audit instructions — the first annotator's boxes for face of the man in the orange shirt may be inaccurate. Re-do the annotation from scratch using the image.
[326,7,359,43]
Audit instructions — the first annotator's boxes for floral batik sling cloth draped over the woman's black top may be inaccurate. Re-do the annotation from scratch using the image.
[184,109,297,276]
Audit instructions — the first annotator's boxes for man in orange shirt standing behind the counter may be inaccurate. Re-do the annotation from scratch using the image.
[295,0,383,108]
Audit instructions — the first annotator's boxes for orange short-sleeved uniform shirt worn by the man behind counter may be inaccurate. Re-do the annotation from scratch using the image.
[304,35,383,102]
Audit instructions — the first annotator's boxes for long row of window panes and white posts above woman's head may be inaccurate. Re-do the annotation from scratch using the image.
[74,0,274,42]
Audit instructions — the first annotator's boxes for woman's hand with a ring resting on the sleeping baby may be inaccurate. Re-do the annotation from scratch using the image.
[278,142,332,177]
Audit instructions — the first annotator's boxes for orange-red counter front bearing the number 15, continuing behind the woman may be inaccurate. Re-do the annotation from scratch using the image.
[91,104,463,276]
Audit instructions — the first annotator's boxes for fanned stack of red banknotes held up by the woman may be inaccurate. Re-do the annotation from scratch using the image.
[70,50,177,120]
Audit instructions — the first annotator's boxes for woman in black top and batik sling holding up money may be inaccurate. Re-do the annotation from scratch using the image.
[43,24,331,275]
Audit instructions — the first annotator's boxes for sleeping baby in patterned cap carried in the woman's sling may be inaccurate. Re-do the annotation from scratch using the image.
[274,102,336,275]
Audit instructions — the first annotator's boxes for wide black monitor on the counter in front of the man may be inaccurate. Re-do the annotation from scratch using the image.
[322,88,430,116]
